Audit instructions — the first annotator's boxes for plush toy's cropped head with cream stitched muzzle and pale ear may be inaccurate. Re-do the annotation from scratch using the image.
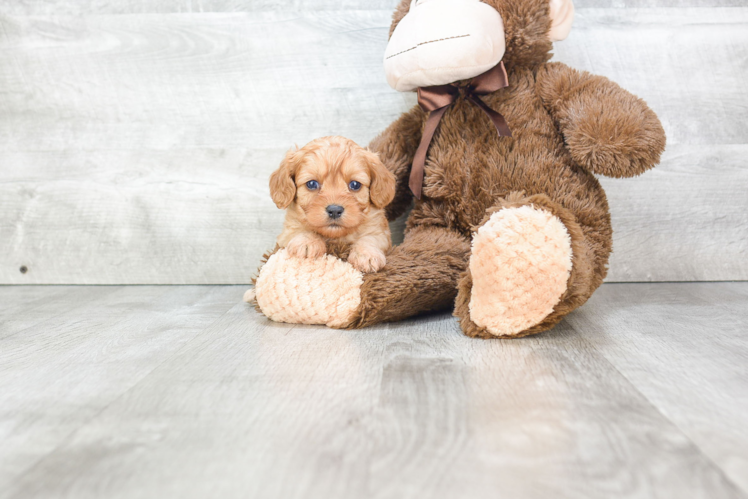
[384,0,574,91]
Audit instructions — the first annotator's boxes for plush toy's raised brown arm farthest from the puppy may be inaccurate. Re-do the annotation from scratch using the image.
[537,63,665,177]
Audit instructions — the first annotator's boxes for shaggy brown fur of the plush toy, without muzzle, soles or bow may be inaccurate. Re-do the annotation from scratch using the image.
[340,0,665,338]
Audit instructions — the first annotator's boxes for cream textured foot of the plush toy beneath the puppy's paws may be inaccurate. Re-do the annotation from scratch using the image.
[254,249,363,328]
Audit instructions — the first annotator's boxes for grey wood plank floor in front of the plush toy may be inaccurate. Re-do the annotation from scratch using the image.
[0,282,748,499]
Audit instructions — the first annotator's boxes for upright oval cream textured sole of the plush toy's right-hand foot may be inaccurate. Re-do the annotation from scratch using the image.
[470,205,572,336]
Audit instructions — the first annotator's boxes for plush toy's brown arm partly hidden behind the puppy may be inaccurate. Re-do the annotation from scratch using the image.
[369,106,426,220]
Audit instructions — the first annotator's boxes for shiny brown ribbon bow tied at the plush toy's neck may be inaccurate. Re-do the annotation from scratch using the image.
[408,62,512,200]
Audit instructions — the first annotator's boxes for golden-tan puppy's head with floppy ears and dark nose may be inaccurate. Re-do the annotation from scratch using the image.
[270,137,395,238]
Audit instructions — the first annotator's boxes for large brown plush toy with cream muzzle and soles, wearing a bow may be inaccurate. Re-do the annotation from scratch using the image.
[253,0,665,338]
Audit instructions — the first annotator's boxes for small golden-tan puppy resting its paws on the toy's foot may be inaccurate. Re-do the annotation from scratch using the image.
[270,137,395,272]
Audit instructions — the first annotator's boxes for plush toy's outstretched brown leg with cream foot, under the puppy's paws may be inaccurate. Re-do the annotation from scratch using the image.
[251,227,470,328]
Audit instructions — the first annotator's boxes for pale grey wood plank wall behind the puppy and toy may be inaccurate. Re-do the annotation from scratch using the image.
[0,0,748,284]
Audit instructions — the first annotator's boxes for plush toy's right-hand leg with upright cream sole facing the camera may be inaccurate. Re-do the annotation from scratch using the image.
[455,193,607,338]
